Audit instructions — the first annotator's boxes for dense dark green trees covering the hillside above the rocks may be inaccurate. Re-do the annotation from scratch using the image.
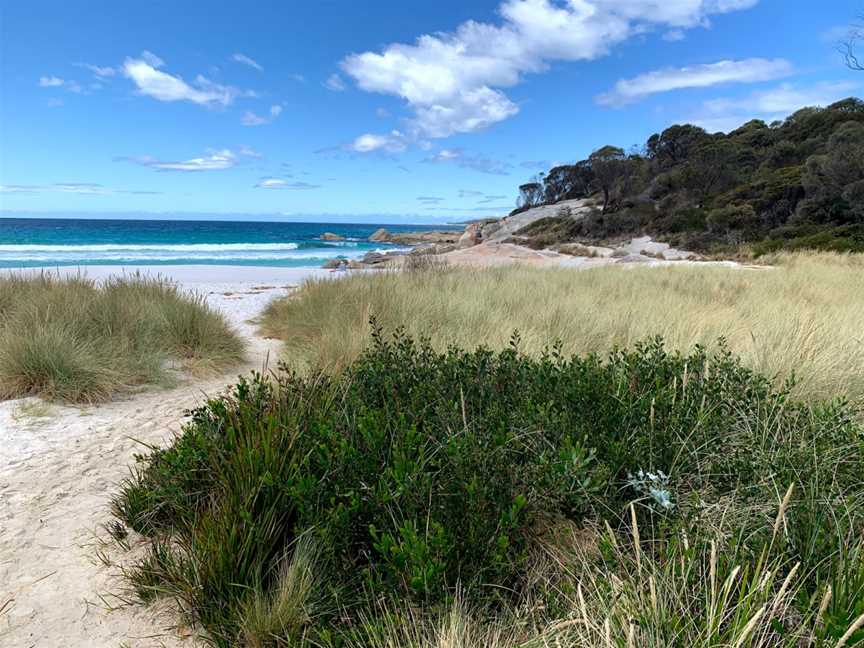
[517,98,864,252]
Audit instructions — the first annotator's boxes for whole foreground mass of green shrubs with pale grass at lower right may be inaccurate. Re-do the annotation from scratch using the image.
[114,329,864,648]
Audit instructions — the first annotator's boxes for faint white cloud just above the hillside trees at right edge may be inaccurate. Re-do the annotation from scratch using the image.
[689,81,861,132]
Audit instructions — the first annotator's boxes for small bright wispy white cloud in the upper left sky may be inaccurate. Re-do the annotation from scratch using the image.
[123,51,246,107]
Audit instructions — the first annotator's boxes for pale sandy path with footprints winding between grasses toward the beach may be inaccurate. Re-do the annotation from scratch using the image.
[0,270,318,648]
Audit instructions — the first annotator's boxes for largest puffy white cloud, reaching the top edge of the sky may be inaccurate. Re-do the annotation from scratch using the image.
[341,0,758,138]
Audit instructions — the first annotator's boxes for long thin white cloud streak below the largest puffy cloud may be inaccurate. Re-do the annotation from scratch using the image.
[597,58,792,106]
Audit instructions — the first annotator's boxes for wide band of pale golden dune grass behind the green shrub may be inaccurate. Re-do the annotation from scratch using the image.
[263,253,864,399]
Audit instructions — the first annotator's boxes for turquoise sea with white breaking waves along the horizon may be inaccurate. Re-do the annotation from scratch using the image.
[0,218,434,268]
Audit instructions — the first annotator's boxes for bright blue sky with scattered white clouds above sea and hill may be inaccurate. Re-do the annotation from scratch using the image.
[0,0,864,222]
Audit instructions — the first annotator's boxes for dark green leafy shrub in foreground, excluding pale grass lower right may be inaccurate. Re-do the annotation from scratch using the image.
[114,331,864,645]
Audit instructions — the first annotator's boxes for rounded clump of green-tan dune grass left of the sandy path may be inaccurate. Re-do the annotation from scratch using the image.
[0,273,243,402]
